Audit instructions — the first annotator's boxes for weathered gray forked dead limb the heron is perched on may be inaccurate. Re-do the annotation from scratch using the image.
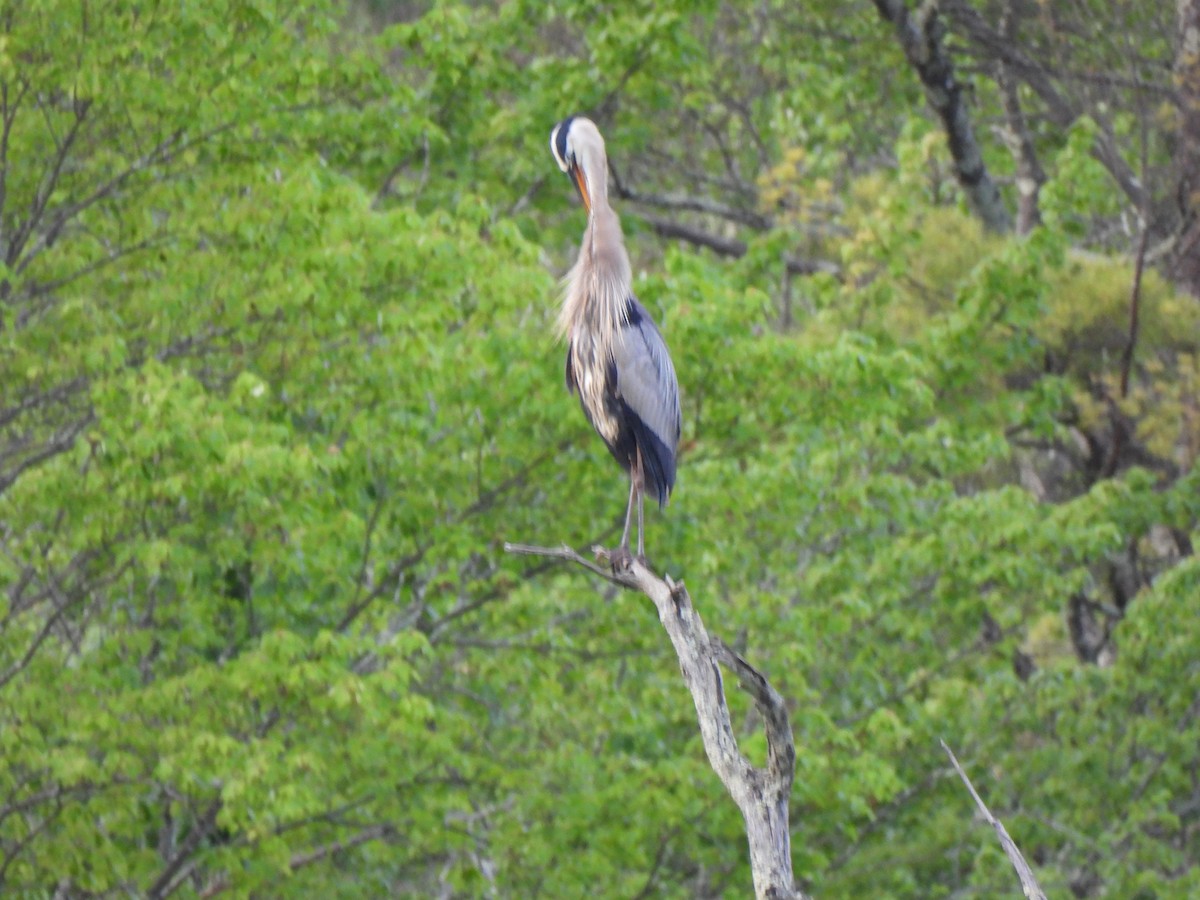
[504,544,804,900]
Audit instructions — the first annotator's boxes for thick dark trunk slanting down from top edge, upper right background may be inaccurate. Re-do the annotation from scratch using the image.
[874,0,1013,232]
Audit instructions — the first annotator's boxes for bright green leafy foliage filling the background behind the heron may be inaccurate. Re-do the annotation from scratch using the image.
[0,0,1200,898]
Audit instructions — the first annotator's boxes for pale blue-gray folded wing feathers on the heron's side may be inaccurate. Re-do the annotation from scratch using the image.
[612,298,682,456]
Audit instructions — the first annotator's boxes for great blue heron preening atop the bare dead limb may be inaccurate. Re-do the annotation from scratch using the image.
[550,116,682,568]
